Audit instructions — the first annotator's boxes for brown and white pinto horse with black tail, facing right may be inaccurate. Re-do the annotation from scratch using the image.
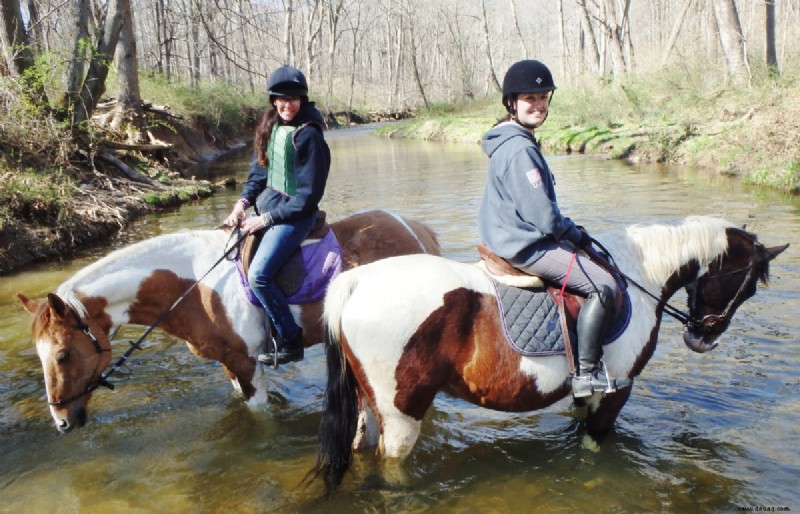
[315,217,788,488]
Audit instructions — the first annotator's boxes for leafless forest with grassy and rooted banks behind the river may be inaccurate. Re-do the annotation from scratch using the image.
[0,0,800,272]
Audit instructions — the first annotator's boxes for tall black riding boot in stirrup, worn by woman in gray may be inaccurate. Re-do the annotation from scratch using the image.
[572,286,631,398]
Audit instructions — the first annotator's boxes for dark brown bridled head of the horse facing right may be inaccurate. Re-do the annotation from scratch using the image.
[683,228,789,353]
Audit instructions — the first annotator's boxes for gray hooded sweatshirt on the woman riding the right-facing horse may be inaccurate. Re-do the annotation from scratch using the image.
[478,122,581,267]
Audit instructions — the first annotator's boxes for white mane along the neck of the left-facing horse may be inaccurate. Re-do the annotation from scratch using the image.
[56,230,228,318]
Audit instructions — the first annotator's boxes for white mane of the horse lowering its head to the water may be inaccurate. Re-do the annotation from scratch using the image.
[56,230,228,317]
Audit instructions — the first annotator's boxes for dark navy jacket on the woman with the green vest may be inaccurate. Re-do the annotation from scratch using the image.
[241,102,331,224]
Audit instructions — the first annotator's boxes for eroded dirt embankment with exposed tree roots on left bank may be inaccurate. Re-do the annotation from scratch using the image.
[0,106,256,274]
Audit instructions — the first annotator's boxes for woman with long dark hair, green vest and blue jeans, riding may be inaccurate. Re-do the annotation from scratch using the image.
[225,66,331,365]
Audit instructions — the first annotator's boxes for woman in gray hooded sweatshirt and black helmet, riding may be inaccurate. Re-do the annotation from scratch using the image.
[478,60,618,398]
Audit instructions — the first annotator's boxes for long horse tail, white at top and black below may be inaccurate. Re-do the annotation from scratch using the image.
[314,269,358,494]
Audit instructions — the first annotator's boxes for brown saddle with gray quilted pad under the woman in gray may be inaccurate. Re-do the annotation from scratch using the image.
[478,244,630,372]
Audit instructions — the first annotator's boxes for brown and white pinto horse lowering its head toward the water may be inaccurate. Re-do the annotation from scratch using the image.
[14,210,440,432]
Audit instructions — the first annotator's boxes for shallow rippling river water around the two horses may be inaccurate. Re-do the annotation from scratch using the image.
[0,125,800,513]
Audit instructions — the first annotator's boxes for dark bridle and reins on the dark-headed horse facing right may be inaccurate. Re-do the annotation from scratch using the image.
[587,238,763,335]
